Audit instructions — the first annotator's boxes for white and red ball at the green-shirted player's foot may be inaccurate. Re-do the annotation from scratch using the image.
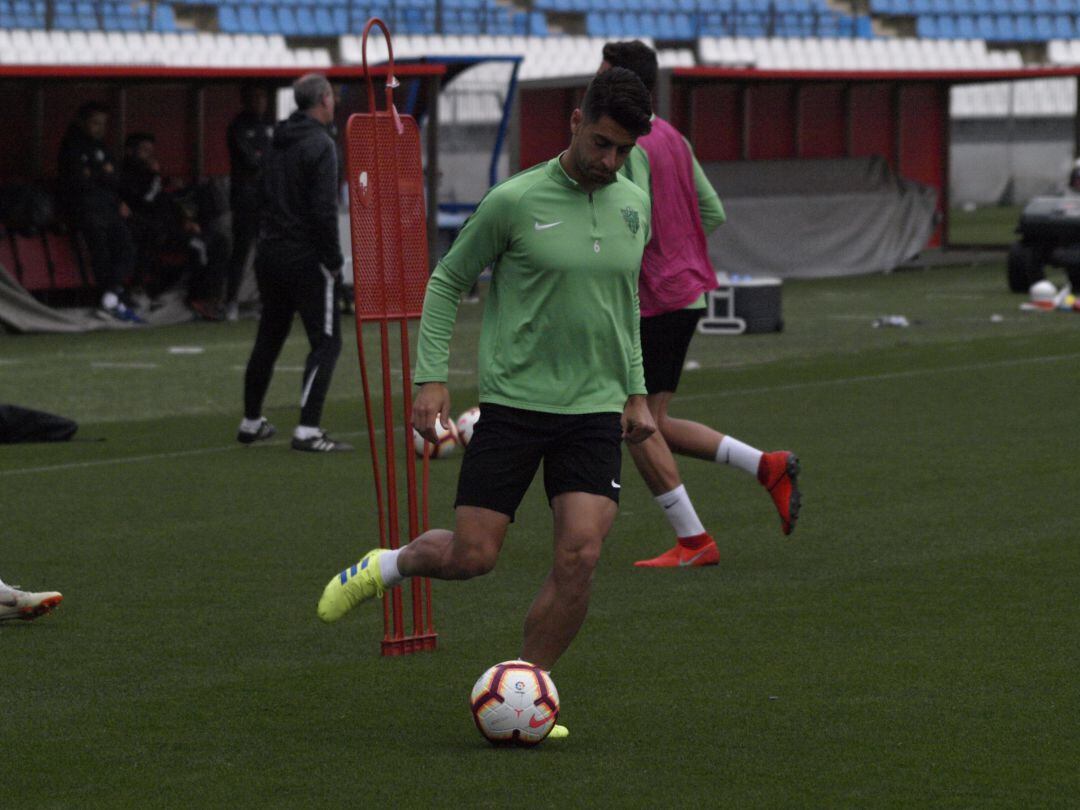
[470,661,558,746]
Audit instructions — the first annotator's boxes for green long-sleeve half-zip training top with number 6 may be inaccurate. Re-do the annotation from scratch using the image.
[414,158,650,414]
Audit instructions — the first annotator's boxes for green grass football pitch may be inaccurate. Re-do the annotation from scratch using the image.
[0,266,1080,808]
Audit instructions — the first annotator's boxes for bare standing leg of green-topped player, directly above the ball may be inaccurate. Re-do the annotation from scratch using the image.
[522,492,619,670]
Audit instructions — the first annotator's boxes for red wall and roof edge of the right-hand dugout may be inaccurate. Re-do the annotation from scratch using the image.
[519,67,1078,246]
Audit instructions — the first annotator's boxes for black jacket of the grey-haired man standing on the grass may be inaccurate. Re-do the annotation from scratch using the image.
[258,111,342,272]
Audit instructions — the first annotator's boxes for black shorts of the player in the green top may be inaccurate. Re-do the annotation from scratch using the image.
[454,403,622,521]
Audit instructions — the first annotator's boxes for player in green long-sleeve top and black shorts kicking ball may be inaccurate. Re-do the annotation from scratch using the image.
[319,69,656,730]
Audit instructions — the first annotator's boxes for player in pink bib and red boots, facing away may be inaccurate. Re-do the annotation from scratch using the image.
[599,41,799,568]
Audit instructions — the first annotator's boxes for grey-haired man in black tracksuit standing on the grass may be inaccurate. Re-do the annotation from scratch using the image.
[237,73,352,453]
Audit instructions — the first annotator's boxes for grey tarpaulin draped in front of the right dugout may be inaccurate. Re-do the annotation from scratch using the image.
[702,158,936,279]
